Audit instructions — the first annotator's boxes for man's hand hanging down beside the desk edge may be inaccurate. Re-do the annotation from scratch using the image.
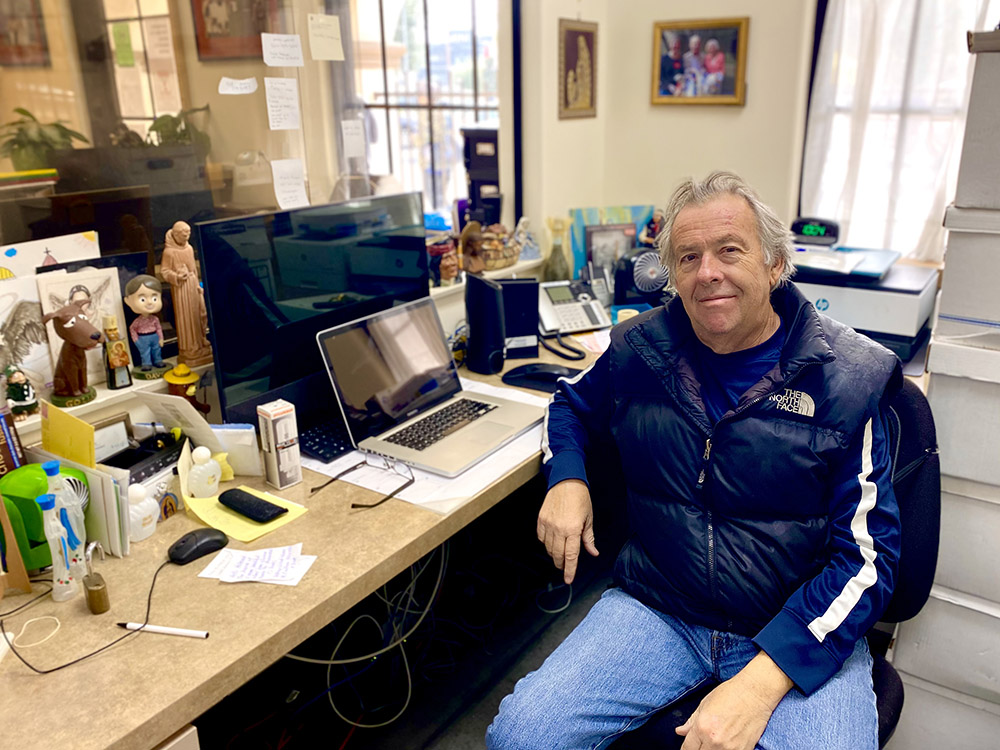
[538,479,598,584]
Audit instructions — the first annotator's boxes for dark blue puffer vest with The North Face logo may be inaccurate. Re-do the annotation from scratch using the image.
[611,284,901,636]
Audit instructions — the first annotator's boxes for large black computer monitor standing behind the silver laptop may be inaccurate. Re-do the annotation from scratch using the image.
[196,193,429,427]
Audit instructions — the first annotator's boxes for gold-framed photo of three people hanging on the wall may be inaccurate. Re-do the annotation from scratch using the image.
[650,17,750,106]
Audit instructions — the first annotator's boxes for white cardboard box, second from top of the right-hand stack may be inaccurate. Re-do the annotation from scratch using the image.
[934,206,1000,349]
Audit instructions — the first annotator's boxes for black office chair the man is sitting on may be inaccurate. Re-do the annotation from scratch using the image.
[610,380,941,750]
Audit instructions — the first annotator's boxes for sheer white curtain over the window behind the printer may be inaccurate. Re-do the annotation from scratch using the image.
[801,0,1000,261]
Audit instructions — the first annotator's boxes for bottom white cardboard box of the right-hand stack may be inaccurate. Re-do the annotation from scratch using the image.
[886,672,1000,750]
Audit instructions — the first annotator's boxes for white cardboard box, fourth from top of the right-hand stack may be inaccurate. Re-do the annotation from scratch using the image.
[934,476,1000,602]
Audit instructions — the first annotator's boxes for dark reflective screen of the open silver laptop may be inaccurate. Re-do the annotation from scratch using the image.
[316,299,461,445]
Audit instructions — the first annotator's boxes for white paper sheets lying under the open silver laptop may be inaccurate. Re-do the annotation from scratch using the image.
[302,378,548,514]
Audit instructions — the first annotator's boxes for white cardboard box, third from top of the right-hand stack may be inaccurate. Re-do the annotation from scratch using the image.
[927,338,1000,485]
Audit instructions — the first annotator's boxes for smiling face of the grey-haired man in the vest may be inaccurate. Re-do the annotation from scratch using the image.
[671,195,784,354]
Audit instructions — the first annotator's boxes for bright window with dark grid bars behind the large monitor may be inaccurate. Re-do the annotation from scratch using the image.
[352,0,499,212]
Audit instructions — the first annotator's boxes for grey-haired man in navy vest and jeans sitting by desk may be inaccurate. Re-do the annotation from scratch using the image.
[487,172,901,750]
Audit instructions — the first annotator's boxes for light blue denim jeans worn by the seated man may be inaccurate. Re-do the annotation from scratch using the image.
[486,589,878,750]
